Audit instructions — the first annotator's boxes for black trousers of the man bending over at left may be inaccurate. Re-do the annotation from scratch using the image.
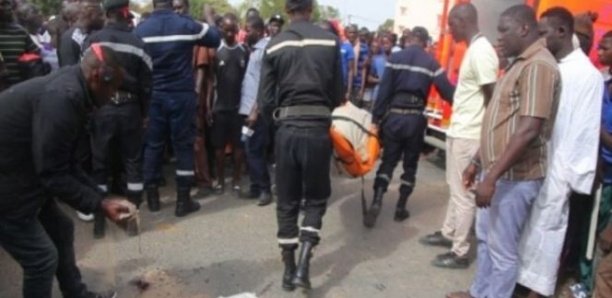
[0,198,87,298]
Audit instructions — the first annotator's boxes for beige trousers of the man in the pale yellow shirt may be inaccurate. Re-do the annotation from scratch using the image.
[442,137,480,257]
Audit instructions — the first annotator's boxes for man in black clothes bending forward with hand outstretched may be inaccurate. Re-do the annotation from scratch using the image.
[0,46,131,298]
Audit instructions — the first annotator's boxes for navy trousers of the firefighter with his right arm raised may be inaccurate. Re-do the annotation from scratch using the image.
[144,91,196,189]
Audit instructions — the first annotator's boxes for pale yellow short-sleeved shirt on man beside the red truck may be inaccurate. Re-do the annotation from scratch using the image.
[446,34,499,140]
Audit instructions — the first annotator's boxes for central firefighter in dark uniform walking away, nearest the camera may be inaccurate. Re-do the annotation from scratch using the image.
[258,0,343,290]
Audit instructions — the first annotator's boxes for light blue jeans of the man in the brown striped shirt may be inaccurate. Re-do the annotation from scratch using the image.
[470,179,543,298]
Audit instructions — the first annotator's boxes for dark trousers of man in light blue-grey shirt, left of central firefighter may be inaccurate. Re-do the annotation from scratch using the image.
[245,117,271,194]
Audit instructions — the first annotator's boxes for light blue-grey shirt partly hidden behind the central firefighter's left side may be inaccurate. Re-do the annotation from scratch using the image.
[238,37,270,116]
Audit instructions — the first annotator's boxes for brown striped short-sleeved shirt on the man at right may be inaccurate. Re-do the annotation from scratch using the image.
[480,40,561,181]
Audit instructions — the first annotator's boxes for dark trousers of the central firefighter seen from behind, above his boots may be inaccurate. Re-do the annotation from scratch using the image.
[276,125,332,249]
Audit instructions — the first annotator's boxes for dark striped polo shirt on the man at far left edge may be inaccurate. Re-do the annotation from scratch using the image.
[0,24,40,86]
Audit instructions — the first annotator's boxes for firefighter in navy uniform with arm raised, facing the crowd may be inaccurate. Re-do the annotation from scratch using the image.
[135,0,220,217]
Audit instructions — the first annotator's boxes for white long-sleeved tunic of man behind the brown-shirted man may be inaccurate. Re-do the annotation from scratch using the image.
[548,48,604,194]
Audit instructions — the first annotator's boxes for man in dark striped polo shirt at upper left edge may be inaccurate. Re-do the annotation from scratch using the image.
[0,0,40,88]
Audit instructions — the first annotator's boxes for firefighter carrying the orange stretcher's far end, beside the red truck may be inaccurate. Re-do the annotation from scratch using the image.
[364,27,455,228]
